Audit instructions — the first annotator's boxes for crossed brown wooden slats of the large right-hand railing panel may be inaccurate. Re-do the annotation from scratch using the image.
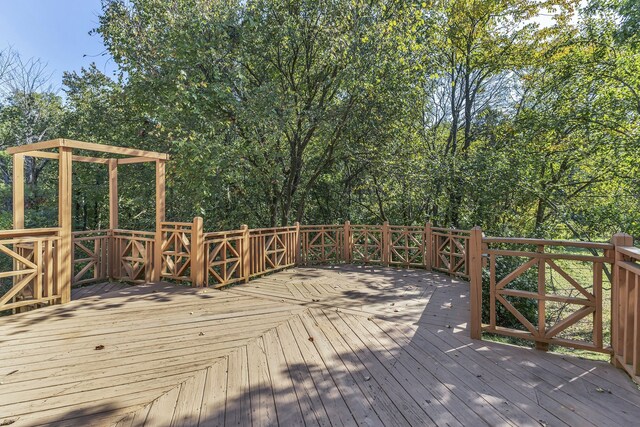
[483,238,613,353]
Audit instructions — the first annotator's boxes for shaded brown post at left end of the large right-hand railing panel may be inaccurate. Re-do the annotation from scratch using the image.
[469,227,482,340]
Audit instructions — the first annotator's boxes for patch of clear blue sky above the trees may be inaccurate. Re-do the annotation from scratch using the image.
[0,0,115,89]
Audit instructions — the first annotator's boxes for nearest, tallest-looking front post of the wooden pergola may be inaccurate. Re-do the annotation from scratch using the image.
[58,147,73,304]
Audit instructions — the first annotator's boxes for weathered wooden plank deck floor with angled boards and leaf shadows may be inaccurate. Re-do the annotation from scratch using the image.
[0,266,640,426]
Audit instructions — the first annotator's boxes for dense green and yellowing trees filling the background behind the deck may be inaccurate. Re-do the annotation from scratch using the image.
[0,0,640,240]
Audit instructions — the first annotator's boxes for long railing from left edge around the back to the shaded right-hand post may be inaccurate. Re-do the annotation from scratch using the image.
[0,221,476,309]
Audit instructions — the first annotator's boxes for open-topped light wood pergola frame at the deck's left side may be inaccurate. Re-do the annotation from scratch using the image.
[6,138,169,303]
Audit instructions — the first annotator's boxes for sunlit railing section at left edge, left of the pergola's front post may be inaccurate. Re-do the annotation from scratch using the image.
[0,228,60,312]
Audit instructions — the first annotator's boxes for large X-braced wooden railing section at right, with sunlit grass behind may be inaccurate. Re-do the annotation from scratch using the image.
[477,238,613,353]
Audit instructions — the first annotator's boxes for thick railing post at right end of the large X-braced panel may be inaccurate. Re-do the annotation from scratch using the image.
[611,233,633,368]
